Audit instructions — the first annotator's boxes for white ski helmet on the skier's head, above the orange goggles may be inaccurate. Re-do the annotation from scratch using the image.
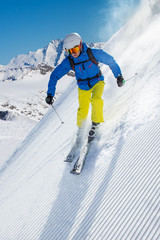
[63,33,82,49]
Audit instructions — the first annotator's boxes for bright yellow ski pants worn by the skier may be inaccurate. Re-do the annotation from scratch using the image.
[77,81,104,127]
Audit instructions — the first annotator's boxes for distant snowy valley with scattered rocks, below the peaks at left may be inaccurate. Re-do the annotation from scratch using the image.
[0,73,73,166]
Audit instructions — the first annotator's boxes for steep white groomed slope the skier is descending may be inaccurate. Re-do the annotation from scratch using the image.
[0,0,160,240]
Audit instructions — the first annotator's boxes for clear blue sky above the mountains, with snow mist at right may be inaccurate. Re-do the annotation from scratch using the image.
[0,0,140,65]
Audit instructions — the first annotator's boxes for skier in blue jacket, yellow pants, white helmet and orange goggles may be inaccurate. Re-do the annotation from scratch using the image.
[46,33,125,141]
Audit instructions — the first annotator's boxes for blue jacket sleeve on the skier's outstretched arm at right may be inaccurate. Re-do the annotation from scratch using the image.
[92,49,122,78]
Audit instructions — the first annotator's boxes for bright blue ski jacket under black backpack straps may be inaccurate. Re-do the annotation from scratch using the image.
[47,43,121,96]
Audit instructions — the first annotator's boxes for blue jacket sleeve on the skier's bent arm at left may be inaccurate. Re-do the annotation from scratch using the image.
[47,57,71,97]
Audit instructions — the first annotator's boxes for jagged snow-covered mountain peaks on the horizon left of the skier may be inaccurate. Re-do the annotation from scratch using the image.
[0,40,64,81]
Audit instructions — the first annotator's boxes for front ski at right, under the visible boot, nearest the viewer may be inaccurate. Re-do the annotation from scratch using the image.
[70,142,90,175]
